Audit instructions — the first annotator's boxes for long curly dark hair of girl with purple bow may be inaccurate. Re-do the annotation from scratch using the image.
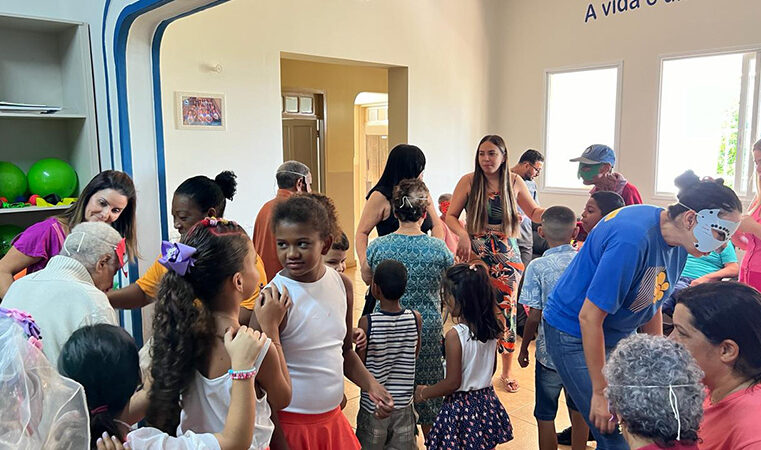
[146,218,251,436]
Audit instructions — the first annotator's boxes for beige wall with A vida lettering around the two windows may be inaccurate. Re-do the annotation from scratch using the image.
[491,0,761,212]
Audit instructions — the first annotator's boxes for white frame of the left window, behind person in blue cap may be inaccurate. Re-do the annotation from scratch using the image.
[539,60,624,196]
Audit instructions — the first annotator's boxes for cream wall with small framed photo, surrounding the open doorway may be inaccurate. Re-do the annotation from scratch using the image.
[161,0,492,231]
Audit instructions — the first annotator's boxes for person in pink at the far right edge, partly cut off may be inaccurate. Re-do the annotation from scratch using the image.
[732,140,761,290]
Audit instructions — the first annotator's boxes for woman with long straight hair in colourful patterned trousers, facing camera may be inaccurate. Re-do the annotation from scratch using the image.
[446,135,544,392]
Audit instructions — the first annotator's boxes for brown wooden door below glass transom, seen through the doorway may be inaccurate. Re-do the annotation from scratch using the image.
[283,119,323,192]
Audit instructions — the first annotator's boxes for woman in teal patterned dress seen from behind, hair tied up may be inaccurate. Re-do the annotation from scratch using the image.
[363,178,454,434]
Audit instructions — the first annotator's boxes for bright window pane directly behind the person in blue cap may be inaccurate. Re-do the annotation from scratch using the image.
[544,66,620,188]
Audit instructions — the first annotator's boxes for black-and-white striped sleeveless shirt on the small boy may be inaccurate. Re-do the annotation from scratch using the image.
[360,309,418,412]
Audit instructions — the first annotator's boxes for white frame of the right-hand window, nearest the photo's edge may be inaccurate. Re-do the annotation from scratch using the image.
[653,45,761,200]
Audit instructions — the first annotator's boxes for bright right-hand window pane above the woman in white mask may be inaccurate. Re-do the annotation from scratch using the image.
[656,51,759,197]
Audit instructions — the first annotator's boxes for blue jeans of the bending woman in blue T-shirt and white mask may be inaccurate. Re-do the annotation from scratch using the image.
[544,321,629,450]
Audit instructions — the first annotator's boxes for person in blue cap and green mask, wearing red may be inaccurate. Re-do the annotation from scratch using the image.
[571,144,642,206]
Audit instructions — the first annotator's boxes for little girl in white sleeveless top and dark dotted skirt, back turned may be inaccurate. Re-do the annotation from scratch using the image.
[415,264,513,450]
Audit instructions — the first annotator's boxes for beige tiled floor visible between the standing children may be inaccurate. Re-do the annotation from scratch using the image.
[344,268,594,449]
